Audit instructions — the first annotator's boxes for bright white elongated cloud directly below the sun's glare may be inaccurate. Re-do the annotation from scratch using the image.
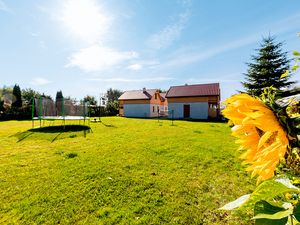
[66,45,138,72]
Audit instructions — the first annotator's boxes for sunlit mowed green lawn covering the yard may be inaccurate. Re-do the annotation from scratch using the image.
[0,117,255,224]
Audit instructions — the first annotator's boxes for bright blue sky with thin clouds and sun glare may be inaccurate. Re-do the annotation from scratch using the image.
[0,0,300,100]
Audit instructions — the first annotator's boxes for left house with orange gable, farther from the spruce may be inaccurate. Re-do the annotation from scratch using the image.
[118,88,168,117]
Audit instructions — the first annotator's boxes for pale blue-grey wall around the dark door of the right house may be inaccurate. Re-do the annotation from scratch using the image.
[168,102,208,119]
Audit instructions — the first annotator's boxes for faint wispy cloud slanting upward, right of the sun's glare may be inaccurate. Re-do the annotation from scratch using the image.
[148,12,189,50]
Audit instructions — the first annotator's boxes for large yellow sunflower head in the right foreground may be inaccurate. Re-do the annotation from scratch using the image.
[223,94,289,184]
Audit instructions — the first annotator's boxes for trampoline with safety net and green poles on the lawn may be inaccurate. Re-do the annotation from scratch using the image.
[32,97,90,128]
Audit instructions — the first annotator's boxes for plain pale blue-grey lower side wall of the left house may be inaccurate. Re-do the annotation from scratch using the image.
[124,104,152,117]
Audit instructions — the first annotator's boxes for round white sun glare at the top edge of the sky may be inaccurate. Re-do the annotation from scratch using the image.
[58,0,112,43]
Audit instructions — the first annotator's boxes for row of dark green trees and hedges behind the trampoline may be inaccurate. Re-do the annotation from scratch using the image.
[0,84,123,120]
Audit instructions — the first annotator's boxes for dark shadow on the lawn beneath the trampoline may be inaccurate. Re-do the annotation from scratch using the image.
[13,125,93,142]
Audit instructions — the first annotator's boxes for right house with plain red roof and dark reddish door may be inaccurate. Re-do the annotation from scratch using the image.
[166,83,220,119]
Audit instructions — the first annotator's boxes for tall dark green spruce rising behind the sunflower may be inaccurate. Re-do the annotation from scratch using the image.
[242,36,295,96]
